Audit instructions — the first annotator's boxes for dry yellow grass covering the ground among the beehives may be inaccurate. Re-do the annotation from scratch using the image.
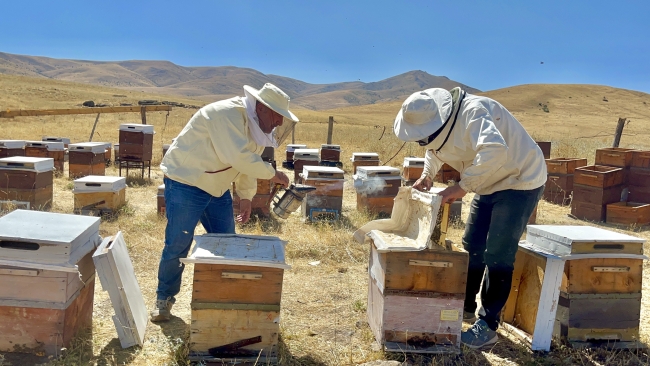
[0,76,650,366]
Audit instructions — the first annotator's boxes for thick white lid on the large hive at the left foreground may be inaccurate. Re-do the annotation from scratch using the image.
[0,210,100,267]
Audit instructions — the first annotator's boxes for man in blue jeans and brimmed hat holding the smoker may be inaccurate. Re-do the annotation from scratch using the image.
[151,83,298,321]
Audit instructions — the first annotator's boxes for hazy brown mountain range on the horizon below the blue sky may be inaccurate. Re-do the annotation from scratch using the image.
[0,52,480,110]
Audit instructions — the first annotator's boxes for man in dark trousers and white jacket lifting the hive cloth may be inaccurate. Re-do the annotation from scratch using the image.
[394,88,546,348]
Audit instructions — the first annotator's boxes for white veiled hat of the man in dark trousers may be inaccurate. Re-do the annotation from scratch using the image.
[393,88,453,142]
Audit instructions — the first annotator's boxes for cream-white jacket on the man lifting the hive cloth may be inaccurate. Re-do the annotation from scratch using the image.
[422,94,546,195]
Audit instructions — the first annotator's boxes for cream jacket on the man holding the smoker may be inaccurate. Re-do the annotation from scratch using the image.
[160,97,275,200]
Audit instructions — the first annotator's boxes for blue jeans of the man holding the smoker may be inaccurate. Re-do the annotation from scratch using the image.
[156,177,235,302]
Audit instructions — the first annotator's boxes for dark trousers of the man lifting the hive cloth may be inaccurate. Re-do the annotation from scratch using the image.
[463,186,544,330]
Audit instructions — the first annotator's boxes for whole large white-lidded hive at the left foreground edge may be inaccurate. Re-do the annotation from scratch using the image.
[0,210,100,355]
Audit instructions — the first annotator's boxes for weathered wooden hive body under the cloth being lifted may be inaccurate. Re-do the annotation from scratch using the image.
[368,242,469,353]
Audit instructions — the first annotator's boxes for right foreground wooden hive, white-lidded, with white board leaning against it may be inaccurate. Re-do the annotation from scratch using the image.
[502,225,646,350]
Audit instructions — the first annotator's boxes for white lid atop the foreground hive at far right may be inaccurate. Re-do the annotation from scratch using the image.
[526,225,645,256]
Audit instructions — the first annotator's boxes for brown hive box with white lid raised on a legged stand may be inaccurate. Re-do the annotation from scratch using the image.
[119,123,154,161]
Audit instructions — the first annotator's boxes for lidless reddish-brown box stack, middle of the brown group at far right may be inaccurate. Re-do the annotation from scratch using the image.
[571,165,625,221]
